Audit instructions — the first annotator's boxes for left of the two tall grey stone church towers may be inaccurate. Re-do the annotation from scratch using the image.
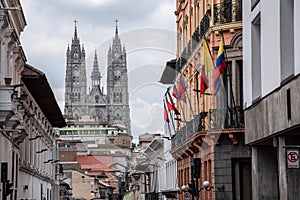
[65,20,87,118]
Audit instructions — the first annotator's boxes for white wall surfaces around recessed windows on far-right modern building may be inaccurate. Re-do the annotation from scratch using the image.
[243,0,300,107]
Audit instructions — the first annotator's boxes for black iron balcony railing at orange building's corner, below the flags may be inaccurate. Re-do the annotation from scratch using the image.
[209,106,244,129]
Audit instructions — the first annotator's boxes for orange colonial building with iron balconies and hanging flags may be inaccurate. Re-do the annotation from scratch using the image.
[163,0,251,199]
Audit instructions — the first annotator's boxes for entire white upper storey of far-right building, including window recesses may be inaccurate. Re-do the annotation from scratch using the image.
[243,0,300,108]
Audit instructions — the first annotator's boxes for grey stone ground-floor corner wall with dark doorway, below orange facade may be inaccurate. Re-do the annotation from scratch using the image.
[213,135,251,200]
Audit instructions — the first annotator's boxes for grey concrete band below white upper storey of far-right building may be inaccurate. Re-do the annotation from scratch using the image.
[245,77,300,143]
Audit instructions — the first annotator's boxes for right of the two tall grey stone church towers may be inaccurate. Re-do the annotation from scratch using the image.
[107,20,131,134]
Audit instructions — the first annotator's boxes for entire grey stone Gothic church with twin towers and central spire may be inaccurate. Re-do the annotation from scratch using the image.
[64,24,131,135]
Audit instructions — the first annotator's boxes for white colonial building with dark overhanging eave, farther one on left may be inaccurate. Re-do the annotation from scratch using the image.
[16,65,66,200]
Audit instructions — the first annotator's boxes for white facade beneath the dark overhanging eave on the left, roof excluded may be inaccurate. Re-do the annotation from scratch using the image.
[19,88,59,200]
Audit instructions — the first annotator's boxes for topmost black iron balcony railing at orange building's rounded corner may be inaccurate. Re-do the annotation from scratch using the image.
[214,0,242,24]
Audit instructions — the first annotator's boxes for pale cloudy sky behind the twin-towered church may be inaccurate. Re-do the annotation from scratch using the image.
[21,0,176,141]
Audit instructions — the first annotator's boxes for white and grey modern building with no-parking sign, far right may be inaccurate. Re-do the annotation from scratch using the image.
[243,0,300,200]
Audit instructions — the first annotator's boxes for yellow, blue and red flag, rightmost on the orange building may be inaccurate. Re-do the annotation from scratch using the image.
[214,38,226,92]
